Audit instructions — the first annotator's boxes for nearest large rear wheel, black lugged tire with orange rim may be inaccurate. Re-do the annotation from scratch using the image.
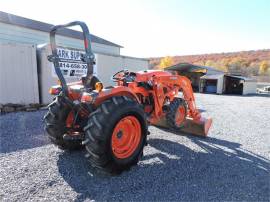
[83,96,148,174]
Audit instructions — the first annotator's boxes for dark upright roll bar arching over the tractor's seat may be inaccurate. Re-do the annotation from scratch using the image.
[48,21,95,93]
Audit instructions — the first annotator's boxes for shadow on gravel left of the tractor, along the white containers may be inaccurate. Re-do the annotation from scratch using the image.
[0,111,49,153]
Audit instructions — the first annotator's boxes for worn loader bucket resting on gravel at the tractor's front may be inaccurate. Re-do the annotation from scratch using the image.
[155,118,212,137]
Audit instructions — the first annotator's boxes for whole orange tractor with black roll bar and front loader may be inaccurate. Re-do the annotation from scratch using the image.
[44,21,212,173]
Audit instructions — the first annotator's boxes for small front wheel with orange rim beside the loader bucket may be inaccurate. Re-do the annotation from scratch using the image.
[166,97,187,131]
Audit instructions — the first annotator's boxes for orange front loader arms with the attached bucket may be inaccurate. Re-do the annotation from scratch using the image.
[150,75,212,137]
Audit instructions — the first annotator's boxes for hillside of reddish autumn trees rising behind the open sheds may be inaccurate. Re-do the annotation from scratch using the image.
[150,49,270,76]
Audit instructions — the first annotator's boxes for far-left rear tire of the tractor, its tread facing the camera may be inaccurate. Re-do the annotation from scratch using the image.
[44,96,82,150]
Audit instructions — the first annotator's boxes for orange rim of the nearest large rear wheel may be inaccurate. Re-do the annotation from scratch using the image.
[112,116,142,159]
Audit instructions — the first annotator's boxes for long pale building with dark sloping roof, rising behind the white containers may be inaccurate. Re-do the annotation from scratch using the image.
[0,11,123,55]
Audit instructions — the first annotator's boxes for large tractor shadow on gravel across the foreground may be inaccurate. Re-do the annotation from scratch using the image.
[58,137,269,201]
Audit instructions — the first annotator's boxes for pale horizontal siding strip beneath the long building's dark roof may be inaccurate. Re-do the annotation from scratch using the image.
[0,22,120,55]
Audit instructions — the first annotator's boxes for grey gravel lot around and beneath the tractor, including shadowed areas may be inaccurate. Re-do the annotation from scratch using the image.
[0,94,270,201]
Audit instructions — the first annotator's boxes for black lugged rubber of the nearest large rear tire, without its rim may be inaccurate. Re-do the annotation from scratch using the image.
[84,96,148,174]
